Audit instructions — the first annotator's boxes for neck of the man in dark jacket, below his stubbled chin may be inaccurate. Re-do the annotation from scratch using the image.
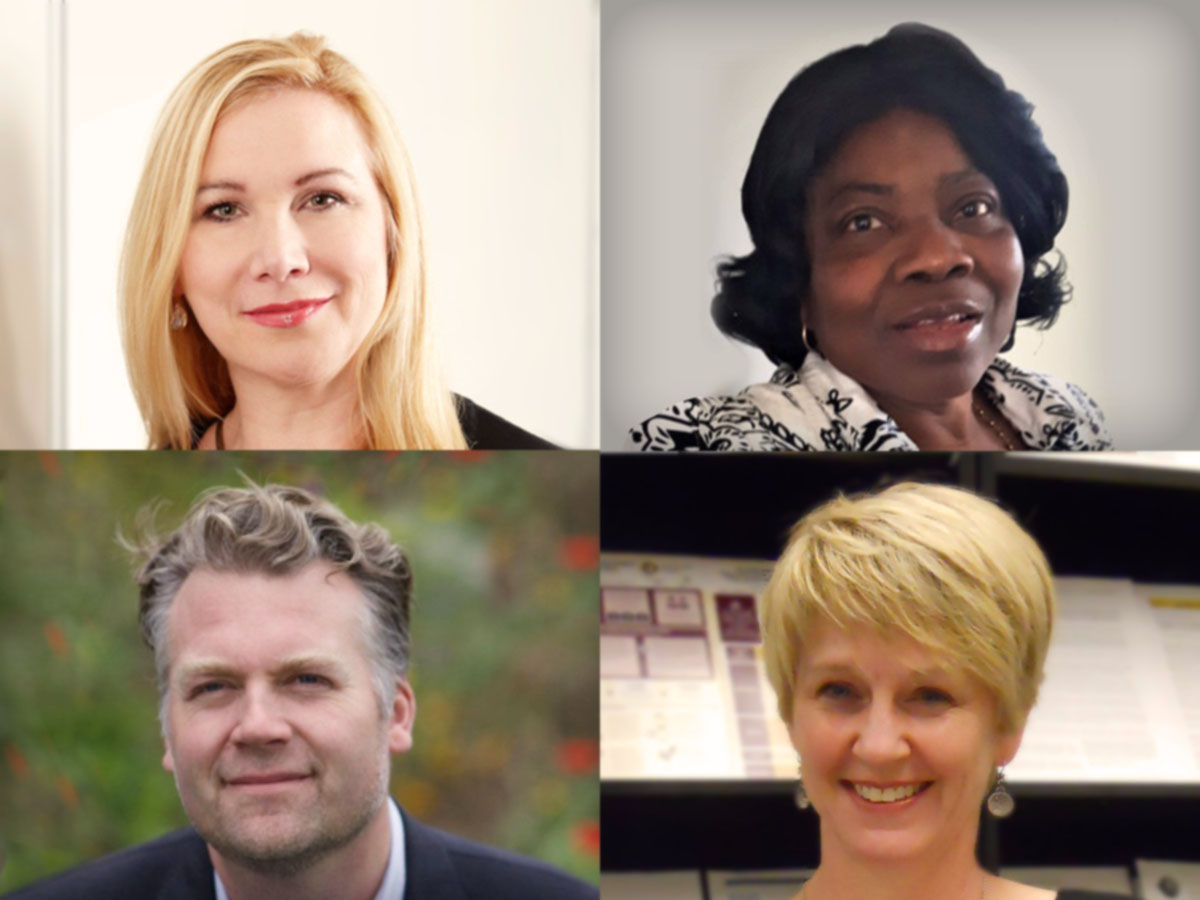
[209,803,391,900]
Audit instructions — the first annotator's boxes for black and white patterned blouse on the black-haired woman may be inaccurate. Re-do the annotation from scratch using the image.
[629,353,1112,450]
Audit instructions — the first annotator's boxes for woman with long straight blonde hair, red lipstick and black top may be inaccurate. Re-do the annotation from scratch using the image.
[120,32,550,450]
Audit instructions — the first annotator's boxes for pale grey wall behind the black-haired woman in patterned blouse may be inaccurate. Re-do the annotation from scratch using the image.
[601,0,1200,450]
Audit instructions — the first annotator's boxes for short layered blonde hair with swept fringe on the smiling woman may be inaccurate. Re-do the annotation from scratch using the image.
[762,484,1055,733]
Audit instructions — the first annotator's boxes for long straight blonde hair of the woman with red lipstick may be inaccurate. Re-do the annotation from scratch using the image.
[119,32,466,449]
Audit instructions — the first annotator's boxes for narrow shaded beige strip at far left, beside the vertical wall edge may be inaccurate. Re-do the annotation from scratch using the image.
[0,0,55,449]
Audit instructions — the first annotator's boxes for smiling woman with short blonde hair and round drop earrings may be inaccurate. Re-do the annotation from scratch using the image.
[763,484,1120,900]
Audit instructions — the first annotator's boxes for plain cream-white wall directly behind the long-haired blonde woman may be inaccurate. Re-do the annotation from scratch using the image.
[63,0,599,448]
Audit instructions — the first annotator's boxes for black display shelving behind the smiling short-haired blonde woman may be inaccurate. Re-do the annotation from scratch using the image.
[600,454,1200,871]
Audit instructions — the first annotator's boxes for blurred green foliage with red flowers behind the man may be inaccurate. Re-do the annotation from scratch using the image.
[0,452,599,893]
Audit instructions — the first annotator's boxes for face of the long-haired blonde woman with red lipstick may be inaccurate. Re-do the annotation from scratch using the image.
[179,89,388,386]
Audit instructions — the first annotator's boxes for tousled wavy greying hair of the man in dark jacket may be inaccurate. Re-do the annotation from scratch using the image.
[131,482,413,713]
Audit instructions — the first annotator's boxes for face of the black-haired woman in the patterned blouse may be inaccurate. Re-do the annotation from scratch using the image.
[804,109,1025,404]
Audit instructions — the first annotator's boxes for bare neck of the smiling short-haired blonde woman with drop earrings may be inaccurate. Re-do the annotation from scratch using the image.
[803,828,994,900]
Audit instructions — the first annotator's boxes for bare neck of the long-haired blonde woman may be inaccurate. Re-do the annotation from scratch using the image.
[222,368,365,450]
